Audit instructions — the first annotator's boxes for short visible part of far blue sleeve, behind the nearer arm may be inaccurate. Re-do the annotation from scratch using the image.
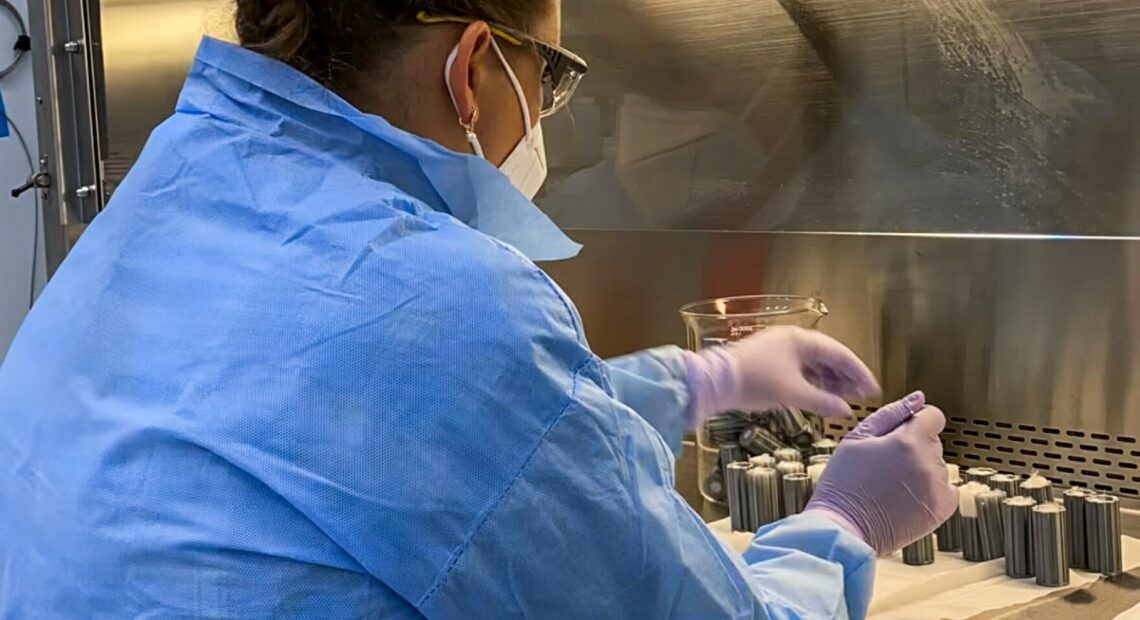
[606,345,689,457]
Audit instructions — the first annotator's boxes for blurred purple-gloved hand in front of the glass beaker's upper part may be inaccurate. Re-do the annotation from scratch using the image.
[685,327,879,427]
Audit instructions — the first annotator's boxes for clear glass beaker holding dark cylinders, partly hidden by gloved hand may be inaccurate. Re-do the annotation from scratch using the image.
[681,295,828,506]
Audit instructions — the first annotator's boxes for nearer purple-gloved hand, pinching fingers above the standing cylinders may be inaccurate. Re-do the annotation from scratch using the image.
[805,392,958,555]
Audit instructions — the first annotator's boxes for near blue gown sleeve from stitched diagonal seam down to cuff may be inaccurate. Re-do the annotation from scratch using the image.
[420,361,874,620]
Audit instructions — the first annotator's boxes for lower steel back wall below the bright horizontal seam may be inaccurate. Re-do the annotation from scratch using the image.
[546,231,1140,501]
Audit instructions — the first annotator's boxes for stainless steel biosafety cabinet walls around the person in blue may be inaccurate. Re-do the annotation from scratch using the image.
[22,0,1140,512]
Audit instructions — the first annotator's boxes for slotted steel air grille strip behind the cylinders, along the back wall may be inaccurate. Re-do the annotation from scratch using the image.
[824,407,1140,508]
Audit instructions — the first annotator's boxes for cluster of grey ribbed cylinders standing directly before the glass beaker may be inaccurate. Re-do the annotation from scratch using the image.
[725,451,824,532]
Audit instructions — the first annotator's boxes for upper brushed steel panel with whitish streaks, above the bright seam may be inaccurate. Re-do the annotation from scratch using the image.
[542,0,1140,235]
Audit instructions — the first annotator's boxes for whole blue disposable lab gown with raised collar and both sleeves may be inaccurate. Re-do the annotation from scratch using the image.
[0,40,873,620]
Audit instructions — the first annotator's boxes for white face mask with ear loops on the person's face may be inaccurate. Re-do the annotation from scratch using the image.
[443,38,546,199]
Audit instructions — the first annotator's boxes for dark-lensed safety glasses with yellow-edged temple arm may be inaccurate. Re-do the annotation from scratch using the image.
[416,11,589,119]
